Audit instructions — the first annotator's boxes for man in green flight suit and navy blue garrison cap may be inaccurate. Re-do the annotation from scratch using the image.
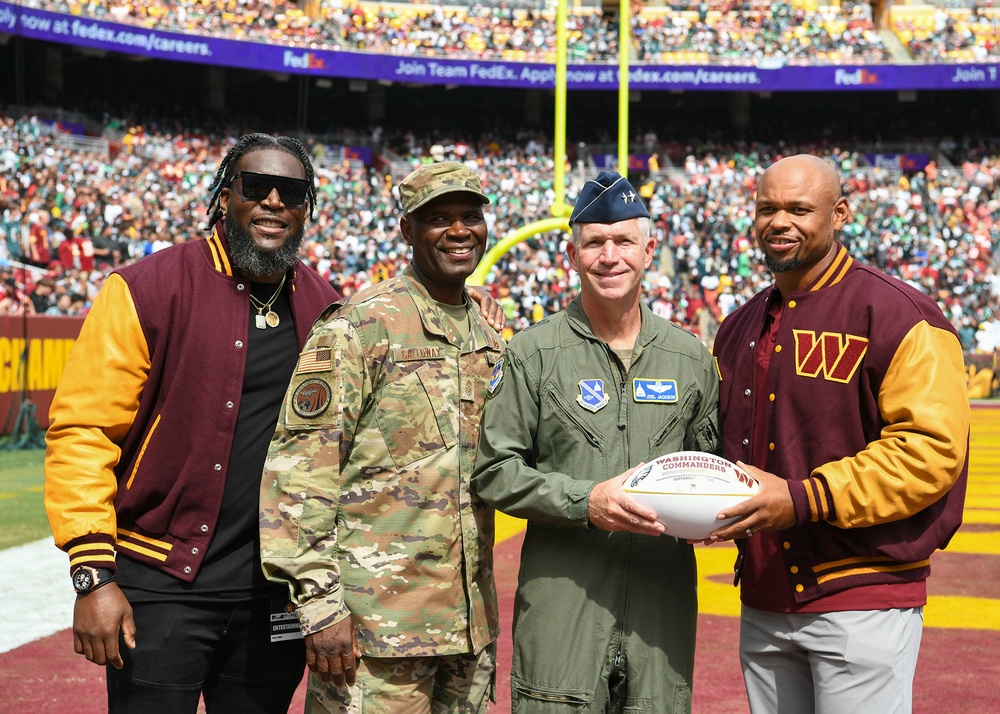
[473,172,719,714]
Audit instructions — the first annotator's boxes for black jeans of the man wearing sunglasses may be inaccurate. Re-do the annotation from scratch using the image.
[106,599,305,714]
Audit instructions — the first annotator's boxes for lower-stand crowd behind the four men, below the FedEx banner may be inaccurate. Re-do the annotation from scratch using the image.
[0,110,1000,352]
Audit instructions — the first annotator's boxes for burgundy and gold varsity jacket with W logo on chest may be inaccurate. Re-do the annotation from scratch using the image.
[714,245,969,604]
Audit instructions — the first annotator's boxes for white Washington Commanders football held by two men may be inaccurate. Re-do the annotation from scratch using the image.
[625,451,757,540]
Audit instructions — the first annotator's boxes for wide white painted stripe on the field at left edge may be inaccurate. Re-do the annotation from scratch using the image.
[0,538,76,652]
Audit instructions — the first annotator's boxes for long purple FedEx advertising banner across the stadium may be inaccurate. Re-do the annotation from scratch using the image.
[0,2,1000,92]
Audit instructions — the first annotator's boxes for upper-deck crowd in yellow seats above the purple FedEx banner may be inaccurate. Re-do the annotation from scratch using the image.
[25,0,1000,64]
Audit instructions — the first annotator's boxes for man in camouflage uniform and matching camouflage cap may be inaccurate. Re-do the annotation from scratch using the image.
[261,162,502,713]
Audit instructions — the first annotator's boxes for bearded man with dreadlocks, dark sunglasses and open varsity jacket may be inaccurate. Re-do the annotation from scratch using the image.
[45,134,339,714]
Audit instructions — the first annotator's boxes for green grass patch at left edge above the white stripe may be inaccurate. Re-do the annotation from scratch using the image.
[0,449,50,549]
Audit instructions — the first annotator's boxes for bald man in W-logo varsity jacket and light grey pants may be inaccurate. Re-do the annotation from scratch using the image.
[713,155,969,712]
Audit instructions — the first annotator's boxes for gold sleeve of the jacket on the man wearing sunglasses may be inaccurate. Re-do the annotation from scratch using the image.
[45,274,150,549]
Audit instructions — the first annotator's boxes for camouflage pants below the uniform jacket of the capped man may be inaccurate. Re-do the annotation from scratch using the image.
[305,642,496,714]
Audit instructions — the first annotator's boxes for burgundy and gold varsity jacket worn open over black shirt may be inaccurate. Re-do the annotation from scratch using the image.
[45,225,339,581]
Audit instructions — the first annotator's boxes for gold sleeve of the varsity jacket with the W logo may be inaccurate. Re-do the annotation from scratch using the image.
[807,321,970,528]
